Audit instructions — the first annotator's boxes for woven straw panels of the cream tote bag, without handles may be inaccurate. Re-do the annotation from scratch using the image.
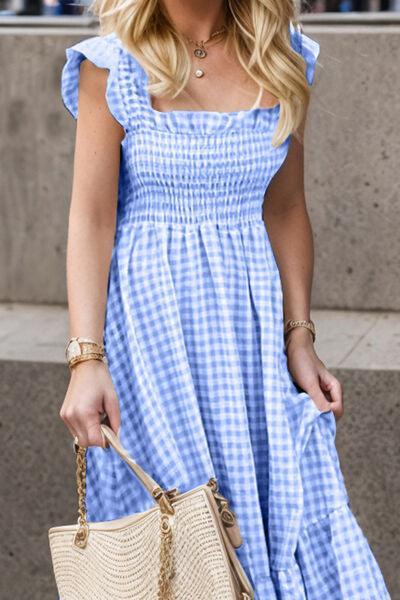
[49,489,240,600]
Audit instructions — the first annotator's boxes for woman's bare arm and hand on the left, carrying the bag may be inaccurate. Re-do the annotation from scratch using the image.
[60,60,124,446]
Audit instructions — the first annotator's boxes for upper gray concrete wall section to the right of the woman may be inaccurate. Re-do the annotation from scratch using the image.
[306,26,400,310]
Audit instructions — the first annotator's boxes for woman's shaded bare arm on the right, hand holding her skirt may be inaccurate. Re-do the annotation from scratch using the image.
[263,120,343,419]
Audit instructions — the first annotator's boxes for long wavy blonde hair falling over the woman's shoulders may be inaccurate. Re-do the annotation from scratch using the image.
[88,0,310,146]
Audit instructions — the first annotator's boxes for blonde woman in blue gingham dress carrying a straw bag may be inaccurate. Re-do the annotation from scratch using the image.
[60,0,389,600]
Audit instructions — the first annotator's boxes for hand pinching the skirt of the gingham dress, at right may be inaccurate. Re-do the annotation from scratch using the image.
[286,327,344,420]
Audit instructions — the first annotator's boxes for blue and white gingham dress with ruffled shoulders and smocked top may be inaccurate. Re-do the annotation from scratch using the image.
[62,27,389,600]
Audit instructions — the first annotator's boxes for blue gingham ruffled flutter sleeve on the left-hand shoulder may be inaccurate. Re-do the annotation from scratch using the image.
[61,36,128,130]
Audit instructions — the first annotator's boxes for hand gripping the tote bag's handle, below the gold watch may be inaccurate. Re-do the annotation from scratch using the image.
[60,360,120,448]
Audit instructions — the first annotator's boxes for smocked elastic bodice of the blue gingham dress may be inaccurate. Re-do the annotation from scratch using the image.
[117,113,287,223]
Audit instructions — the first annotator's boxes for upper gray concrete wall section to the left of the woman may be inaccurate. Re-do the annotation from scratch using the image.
[0,30,90,302]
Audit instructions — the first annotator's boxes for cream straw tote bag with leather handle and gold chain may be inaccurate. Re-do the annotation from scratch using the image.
[48,424,254,600]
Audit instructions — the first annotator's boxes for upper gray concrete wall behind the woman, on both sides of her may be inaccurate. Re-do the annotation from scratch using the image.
[0,24,400,310]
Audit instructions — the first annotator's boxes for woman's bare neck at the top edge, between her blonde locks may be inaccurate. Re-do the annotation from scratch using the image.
[159,0,225,40]
